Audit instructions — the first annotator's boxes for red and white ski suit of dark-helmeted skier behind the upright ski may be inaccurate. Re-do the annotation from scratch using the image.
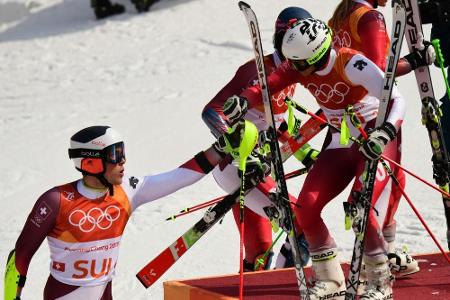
[202,52,295,262]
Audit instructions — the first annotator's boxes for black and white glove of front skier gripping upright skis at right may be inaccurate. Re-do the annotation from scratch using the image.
[359,122,397,160]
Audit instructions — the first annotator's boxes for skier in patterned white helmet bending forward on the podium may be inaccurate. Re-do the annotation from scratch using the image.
[236,19,422,299]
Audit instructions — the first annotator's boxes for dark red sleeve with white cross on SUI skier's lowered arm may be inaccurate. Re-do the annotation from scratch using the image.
[15,188,60,276]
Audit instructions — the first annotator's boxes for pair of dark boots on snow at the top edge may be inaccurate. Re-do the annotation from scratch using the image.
[91,0,158,20]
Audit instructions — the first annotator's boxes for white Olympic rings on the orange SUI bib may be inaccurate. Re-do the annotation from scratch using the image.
[69,205,120,232]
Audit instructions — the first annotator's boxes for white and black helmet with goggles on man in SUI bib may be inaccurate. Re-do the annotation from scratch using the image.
[69,126,125,175]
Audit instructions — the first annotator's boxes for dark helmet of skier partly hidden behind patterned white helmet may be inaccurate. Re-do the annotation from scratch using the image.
[273,6,312,56]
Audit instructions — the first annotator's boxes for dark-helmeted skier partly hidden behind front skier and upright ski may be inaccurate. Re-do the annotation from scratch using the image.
[202,7,318,271]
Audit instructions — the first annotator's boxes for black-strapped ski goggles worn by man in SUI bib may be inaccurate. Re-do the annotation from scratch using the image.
[69,142,125,164]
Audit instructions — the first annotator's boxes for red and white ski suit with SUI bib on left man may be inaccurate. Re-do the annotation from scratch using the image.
[15,159,212,300]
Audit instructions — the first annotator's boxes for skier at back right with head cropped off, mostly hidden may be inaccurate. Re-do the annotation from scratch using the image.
[328,0,435,276]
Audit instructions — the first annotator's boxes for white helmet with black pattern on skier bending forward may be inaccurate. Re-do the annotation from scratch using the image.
[282,18,332,65]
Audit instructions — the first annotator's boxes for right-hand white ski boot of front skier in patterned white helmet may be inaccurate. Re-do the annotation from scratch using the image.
[359,255,394,300]
